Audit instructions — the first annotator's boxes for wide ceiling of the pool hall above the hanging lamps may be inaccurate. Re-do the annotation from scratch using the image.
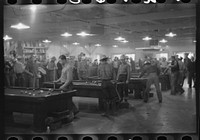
[4,4,196,46]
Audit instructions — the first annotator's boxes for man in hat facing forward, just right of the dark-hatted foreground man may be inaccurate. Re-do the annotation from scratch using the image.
[117,55,130,102]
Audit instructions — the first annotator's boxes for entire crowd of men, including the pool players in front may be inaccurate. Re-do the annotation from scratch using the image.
[4,50,196,115]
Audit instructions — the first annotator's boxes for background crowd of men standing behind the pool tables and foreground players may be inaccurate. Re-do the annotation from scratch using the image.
[4,50,196,95]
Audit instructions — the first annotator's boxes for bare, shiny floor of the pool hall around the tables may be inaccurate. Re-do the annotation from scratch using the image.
[5,79,197,134]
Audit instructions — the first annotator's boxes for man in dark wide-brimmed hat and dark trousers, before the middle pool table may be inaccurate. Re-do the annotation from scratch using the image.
[98,55,119,116]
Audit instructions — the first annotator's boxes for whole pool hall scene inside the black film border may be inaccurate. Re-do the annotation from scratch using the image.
[3,3,199,134]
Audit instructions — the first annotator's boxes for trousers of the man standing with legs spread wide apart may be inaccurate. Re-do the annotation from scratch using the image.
[144,73,162,102]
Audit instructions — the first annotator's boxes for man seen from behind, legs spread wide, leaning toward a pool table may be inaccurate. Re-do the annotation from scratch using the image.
[139,59,162,103]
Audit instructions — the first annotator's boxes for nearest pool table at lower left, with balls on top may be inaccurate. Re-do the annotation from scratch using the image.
[4,87,76,132]
